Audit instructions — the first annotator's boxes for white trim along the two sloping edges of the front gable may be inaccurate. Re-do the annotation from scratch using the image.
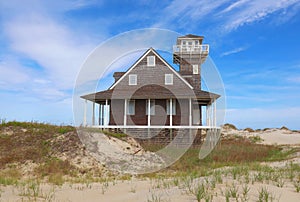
[109,48,193,90]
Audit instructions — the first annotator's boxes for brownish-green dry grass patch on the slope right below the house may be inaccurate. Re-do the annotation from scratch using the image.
[143,137,296,176]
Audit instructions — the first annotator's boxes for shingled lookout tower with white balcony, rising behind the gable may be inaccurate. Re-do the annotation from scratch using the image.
[173,34,209,89]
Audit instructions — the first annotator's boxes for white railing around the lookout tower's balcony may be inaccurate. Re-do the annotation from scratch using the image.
[173,44,209,54]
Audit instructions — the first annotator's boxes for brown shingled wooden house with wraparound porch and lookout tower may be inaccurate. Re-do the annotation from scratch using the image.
[81,34,219,143]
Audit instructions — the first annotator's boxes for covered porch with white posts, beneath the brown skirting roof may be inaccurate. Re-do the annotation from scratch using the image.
[83,98,219,130]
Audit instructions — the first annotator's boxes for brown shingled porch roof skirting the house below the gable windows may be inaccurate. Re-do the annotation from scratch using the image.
[81,85,220,103]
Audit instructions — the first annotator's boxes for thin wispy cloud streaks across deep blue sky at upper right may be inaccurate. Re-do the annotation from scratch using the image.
[154,0,300,32]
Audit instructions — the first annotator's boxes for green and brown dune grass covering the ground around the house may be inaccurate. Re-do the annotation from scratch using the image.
[0,120,300,201]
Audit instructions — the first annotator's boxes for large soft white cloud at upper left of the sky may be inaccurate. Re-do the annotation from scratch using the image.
[4,15,92,88]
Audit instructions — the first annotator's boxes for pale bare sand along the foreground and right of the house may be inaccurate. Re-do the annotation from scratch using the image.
[0,129,300,202]
